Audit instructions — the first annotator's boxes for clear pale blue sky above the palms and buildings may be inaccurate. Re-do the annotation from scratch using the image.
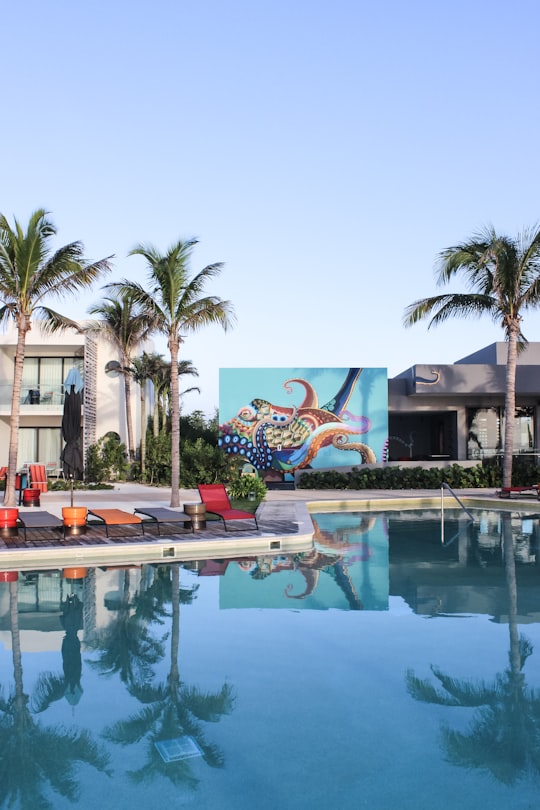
[0,0,540,413]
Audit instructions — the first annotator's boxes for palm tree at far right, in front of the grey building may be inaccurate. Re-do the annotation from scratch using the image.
[404,225,540,487]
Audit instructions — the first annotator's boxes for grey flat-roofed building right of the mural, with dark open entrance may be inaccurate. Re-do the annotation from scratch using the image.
[388,343,540,461]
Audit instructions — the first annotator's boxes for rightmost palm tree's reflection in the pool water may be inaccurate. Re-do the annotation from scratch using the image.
[406,514,540,784]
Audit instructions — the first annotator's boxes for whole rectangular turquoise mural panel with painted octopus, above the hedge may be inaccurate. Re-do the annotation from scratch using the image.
[219,368,388,473]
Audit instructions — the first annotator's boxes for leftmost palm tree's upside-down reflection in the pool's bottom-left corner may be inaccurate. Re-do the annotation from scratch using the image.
[0,582,109,810]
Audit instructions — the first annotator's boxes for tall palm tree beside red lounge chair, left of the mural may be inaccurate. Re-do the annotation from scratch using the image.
[107,239,234,506]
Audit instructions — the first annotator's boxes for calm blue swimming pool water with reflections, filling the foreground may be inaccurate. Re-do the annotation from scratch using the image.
[0,510,540,810]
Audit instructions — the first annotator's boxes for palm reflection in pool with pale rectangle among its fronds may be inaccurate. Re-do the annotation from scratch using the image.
[105,565,234,787]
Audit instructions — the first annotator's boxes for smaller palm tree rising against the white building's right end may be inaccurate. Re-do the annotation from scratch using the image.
[85,291,152,461]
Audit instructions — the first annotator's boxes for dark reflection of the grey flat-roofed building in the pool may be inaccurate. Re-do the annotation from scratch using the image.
[388,511,540,624]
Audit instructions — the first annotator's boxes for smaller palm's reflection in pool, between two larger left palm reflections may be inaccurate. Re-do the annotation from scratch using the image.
[89,570,164,686]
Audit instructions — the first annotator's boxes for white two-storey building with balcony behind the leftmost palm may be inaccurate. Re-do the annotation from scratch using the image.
[0,322,147,466]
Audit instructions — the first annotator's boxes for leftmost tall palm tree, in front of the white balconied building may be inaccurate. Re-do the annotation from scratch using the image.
[0,208,112,506]
